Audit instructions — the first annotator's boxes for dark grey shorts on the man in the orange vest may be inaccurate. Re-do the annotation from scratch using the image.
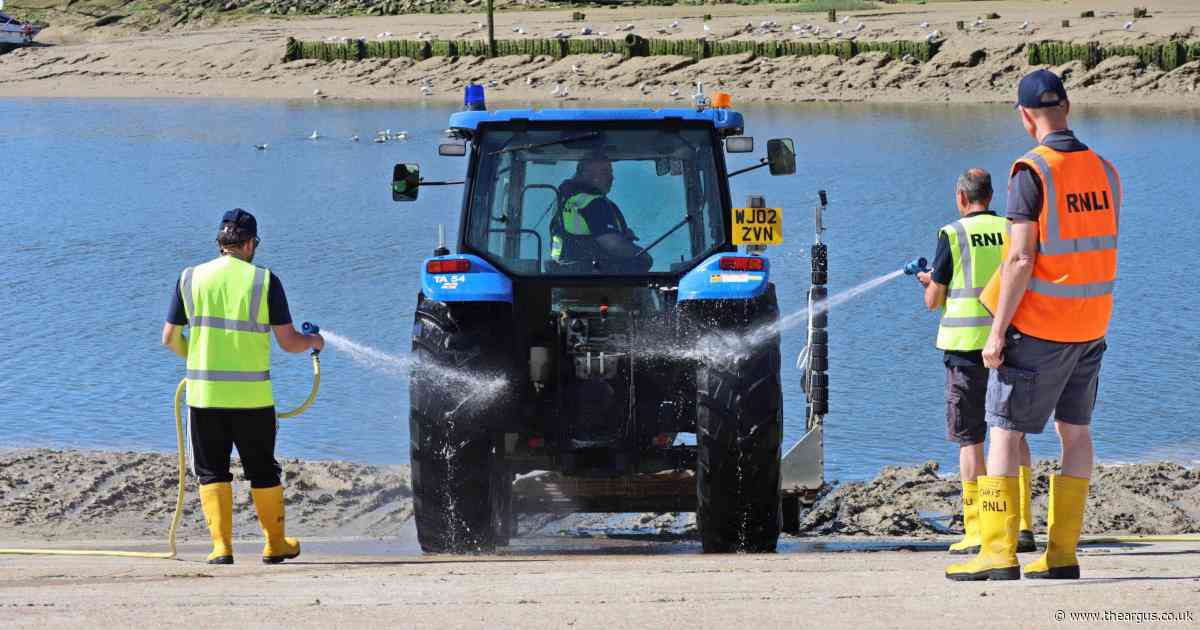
[986,328,1108,433]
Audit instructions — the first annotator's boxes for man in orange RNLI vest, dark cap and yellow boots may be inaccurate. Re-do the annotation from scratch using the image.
[946,70,1121,580]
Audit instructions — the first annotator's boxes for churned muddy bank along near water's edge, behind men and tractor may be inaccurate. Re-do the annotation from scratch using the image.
[0,449,1200,541]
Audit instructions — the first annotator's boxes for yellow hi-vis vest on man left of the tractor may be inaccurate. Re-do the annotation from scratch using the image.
[180,256,275,409]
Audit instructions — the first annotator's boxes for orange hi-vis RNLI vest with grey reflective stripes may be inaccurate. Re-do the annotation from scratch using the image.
[1013,146,1122,342]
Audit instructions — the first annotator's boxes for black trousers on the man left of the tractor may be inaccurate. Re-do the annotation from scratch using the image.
[188,407,283,488]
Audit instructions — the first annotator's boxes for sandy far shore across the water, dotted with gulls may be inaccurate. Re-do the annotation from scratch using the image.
[0,0,1200,108]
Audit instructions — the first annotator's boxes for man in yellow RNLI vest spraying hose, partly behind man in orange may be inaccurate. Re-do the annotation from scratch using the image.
[917,168,1037,554]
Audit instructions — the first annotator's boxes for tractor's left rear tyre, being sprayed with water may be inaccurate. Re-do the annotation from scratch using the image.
[409,300,512,553]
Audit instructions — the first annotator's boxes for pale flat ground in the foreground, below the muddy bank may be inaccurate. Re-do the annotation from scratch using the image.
[0,544,1200,630]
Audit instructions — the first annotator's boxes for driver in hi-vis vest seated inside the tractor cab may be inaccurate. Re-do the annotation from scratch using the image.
[550,155,654,271]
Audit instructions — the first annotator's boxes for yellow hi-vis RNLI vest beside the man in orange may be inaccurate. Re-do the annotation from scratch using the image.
[937,215,1008,352]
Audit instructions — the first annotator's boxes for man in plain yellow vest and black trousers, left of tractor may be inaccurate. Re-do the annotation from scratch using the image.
[162,208,325,564]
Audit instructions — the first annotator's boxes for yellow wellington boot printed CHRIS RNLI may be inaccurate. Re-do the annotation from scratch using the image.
[946,476,1021,581]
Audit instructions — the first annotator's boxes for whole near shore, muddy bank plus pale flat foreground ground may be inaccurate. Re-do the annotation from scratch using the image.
[0,450,1200,629]
